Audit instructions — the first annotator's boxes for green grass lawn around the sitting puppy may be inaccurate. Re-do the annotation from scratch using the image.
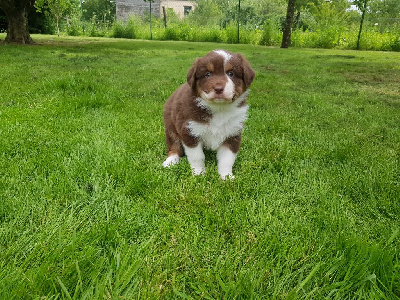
[0,34,400,299]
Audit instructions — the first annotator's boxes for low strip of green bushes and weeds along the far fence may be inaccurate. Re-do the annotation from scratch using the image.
[60,12,400,51]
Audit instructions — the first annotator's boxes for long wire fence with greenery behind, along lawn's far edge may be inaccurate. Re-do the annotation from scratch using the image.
[0,0,400,51]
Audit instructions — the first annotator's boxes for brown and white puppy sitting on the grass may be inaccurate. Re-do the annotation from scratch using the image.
[163,50,255,179]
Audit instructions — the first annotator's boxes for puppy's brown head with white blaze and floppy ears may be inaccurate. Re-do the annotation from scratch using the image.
[187,50,255,103]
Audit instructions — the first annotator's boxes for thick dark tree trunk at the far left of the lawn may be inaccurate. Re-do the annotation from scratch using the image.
[0,0,36,44]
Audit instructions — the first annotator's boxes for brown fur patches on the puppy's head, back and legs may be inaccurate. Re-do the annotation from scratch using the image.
[164,51,255,161]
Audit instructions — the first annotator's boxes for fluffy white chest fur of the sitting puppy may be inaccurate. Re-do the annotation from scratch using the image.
[187,93,249,150]
